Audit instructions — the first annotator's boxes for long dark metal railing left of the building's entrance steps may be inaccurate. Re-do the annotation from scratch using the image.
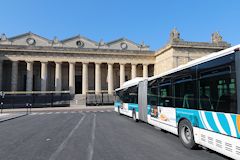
[0,91,73,112]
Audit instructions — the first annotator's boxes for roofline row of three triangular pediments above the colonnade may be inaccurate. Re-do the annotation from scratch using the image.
[0,32,149,51]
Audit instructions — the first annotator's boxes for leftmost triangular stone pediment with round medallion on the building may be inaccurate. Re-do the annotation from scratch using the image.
[9,32,51,46]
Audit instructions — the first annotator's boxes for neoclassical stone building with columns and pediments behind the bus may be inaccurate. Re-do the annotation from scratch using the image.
[0,29,230,98]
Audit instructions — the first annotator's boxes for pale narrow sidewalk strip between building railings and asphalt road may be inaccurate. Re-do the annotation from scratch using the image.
[3,105,114,113]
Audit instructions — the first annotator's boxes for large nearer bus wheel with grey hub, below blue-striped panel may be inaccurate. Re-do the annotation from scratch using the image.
[178,119,197,149]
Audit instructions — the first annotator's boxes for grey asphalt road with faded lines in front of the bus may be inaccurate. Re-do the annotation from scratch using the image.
[0,111,230,160]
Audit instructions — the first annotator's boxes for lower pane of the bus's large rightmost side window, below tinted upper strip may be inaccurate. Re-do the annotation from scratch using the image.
[199,68,237,113]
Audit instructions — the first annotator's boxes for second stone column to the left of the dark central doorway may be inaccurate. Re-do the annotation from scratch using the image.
[55,62,62,91]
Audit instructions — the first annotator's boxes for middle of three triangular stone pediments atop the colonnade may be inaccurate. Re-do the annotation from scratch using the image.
[61,35,98,48]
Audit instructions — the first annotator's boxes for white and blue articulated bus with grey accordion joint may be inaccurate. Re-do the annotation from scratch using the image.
[114,45,240,160]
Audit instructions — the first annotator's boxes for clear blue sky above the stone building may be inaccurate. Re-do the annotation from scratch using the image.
[0,0,240,50]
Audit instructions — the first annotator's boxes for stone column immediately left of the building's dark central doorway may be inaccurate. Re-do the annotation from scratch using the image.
[68,62,75,94]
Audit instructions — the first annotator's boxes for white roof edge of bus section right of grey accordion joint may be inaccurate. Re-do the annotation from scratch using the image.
[148,44,240,80]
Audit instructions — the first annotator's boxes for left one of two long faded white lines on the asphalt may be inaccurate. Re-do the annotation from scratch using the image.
[49,113,85,160]
